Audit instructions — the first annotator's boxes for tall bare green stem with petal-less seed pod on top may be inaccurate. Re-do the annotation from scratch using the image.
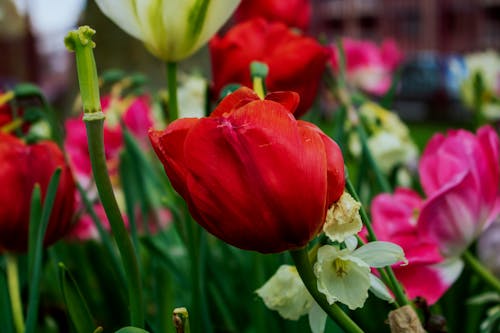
[65,26,144,328]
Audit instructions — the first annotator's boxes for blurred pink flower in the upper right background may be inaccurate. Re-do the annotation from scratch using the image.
[330,38,403,95]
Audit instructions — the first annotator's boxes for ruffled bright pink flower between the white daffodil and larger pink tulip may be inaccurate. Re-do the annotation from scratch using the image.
[371,188,462,304]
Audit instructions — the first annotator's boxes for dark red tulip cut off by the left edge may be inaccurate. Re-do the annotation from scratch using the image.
[0,133,75,252]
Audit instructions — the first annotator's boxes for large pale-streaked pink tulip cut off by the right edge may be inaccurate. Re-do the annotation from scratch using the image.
[418,126,500,257]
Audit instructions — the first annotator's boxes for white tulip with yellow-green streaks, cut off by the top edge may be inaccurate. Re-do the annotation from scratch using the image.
[96,0,240,61]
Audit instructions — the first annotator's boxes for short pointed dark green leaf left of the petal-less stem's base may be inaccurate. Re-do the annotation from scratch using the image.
[59,263,95,333]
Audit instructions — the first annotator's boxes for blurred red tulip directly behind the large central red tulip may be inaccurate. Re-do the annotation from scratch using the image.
[209,19,328,117]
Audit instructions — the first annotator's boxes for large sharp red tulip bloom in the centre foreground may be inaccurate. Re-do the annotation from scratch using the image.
[149,87,344,253]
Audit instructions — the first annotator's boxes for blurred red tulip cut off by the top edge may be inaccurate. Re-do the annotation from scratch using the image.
[235,0,312,30]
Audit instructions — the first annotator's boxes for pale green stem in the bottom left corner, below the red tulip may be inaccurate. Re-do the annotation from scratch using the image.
[5,253,25,333]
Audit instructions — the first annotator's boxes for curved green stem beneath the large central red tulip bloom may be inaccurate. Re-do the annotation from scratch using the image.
[290,247,363,333]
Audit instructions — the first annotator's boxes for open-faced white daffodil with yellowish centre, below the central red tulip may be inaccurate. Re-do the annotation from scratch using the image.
[314,242,406,310]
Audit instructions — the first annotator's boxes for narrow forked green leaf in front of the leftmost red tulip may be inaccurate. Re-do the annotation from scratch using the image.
[25,168,61,333]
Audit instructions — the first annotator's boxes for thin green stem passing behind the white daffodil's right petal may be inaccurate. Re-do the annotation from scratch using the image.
[346,177,411,306]
